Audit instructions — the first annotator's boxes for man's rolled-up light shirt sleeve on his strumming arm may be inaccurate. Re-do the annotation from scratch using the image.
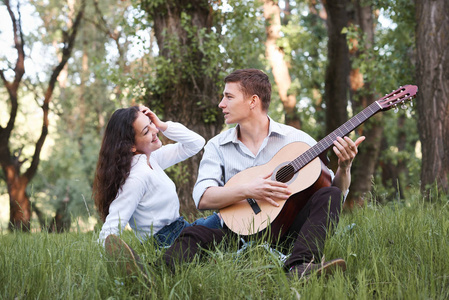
[192,139,224,207]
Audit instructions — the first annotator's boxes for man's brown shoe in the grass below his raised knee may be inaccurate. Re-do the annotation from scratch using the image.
[288,258,346,279]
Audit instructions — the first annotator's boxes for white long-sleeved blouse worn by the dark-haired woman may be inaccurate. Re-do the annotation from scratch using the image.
[99,121,205,244]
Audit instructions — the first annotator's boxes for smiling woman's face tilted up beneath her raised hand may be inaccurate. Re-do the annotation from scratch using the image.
[132,111,162,157]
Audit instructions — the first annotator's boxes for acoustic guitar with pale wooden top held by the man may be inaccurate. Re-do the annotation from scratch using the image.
[220,85,418,238]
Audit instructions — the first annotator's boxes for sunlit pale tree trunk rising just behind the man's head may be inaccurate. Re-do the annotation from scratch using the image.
[263,0,301,129]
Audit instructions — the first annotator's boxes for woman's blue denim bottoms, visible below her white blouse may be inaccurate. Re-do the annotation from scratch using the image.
[153,213,222,248]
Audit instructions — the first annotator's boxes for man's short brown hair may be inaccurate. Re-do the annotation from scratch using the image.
[224,69,271,111]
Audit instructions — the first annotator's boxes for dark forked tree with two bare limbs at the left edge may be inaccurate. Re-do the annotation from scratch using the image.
[0,1,85,230]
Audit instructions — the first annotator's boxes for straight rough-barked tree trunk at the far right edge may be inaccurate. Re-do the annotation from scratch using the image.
[416,0,449,193]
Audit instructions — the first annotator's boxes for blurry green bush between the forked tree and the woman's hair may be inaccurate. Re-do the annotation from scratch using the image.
[29,134,100,222]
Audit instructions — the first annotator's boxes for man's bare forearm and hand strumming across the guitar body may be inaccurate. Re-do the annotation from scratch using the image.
[198,172,291,209]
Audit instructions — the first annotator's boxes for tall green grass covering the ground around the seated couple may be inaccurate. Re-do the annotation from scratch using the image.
[0,197,449,299]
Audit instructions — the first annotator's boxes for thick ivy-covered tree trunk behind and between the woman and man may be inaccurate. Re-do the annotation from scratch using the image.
[142,0,223,215]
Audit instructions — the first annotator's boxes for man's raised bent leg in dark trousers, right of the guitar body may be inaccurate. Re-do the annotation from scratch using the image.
[285,187,342,269]
